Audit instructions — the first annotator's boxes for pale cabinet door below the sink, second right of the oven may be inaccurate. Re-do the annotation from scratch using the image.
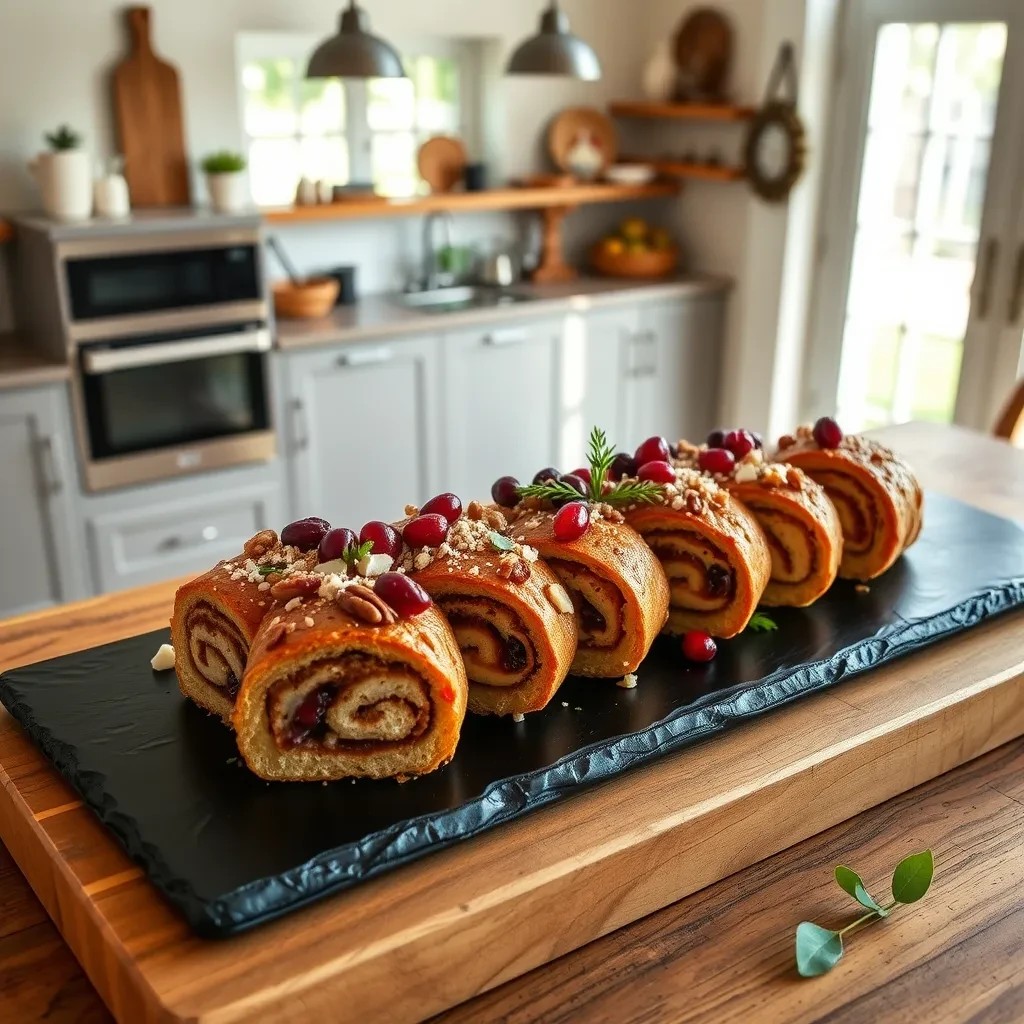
[443,319,562,501]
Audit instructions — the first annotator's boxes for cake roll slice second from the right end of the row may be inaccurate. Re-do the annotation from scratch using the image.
[673,441,843,608]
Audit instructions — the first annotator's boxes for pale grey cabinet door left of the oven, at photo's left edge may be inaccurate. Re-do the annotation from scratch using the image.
[0,384,86,617]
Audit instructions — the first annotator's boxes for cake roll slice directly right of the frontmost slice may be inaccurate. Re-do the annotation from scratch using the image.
[397,502,578,715]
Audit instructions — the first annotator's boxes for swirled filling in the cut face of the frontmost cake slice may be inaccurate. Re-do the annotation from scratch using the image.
[266,651,432,755]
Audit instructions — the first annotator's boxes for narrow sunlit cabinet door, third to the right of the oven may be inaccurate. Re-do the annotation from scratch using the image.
[555,305,638,469]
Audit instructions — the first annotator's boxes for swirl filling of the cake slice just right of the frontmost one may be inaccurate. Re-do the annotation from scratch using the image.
[436,595,540,686]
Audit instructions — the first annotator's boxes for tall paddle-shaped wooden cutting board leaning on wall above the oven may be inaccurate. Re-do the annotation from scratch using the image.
[114,7,190,207]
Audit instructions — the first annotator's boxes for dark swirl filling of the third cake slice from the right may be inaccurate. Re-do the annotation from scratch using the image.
[644,529,736,614]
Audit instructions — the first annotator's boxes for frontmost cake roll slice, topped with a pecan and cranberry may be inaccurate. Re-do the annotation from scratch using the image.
[232,572,467,781]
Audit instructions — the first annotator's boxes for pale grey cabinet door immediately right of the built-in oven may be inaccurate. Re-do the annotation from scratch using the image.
[283,337,439,531]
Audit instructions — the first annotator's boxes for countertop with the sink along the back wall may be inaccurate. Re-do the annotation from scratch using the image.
[276,274,732,351]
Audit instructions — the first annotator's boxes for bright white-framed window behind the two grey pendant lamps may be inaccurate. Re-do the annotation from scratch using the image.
[238,33,479,206]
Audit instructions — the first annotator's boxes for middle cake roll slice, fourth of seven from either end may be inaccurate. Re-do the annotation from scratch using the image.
[511,499,669,679]
